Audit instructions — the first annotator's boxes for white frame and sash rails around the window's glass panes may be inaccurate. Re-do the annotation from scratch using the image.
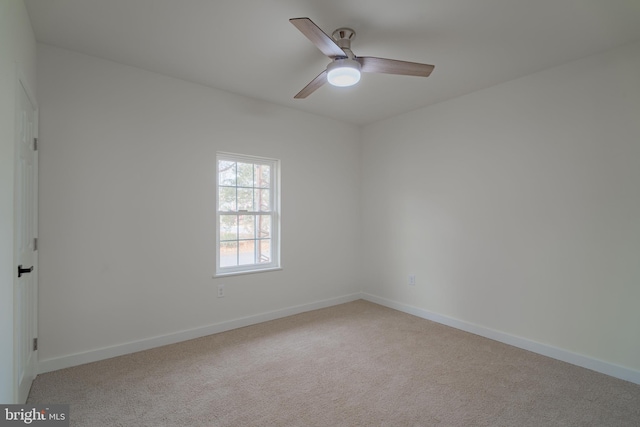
[215,152,281,277]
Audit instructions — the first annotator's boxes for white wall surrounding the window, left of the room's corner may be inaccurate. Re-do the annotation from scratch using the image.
[38,45,360,369]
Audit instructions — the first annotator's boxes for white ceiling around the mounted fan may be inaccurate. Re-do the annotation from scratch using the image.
[25,0,640,125]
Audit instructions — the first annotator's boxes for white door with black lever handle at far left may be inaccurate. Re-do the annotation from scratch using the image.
[13,77,38,403]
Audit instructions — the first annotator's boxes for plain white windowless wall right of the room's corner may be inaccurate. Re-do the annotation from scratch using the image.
[362,39,640,378]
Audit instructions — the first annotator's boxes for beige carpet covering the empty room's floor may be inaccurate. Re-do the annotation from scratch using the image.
[28,301,640,427]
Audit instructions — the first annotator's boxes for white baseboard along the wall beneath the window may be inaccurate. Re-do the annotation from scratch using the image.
[38,293,362,374]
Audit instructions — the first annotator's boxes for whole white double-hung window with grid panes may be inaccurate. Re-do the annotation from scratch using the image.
[216,153,280,276]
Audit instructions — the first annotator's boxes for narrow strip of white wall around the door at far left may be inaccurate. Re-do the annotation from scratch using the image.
[0,0,36,403]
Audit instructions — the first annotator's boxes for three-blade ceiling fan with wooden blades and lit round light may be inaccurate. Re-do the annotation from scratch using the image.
[289,18,434,99]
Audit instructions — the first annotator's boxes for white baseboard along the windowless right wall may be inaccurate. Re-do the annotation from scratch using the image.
[362,293,640,384]
